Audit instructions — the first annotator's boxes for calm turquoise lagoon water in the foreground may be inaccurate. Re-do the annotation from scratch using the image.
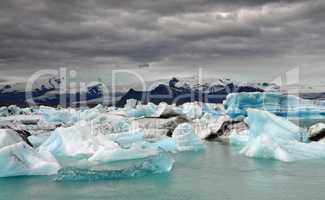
[0,142,325,200]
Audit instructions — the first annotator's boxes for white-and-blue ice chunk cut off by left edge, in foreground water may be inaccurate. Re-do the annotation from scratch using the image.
[0,142,60,177]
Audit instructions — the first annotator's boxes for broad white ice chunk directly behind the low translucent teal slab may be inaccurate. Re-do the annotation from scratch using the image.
[39,121,158,165]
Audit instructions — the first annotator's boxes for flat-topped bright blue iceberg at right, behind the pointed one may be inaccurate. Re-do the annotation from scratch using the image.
[224,92,325,120]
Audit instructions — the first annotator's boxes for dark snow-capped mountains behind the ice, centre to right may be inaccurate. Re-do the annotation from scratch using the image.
[117,78,270,107]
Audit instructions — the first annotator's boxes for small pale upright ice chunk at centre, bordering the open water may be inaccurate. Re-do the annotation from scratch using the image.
[172,123,204,151]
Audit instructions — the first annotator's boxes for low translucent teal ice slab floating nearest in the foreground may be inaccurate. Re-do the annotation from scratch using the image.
[56,153,174,181]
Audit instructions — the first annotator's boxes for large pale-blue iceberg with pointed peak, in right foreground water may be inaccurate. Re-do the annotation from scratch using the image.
[230,109,325,162]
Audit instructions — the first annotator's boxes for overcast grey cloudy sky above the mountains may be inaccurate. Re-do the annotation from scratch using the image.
[0,0,325,85]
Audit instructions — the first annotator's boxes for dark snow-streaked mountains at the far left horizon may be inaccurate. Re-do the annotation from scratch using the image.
[0,77,102,107]
